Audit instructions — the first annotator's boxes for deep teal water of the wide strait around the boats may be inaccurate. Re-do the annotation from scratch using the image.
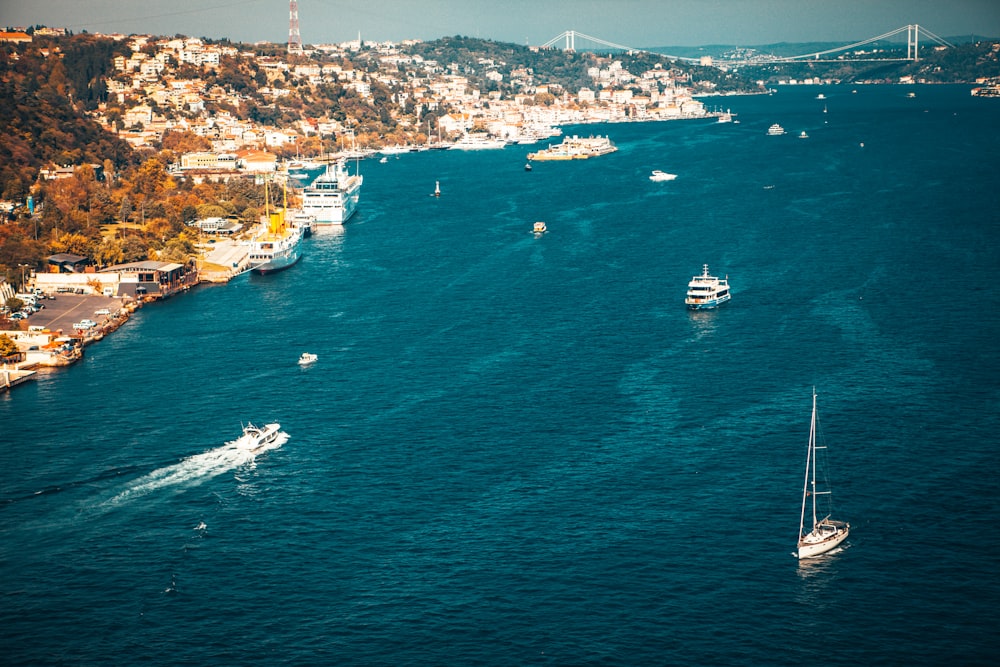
[0,85,1000,666]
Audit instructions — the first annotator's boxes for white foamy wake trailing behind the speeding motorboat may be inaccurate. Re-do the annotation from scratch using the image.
[102,432,288,506]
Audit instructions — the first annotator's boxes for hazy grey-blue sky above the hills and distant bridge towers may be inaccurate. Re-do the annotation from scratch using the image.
[0,0,1000,47]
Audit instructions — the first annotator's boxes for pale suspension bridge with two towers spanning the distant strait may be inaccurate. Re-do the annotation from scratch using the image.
[542,24,954,65]
